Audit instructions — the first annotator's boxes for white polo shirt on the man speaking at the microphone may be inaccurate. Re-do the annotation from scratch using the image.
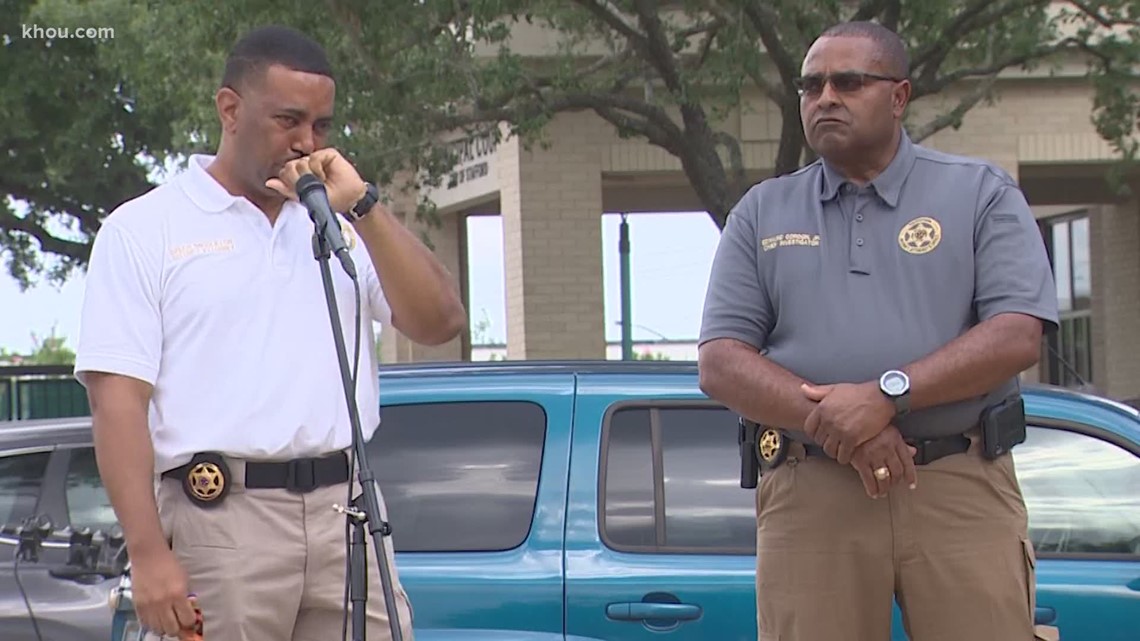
[75,155,391,472]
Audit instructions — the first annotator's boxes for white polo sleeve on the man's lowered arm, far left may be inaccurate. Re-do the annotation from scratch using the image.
[75,219,162,386]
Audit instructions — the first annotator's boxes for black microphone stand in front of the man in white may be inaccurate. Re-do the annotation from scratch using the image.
[307,200,404,641]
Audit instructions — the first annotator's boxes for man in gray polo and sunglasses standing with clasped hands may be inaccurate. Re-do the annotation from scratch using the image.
[700,23,1057,641]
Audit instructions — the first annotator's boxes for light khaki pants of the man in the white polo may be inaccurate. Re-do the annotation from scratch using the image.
[148,461,414,641]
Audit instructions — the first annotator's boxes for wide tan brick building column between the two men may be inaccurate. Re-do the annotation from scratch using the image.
[499,113,605,360]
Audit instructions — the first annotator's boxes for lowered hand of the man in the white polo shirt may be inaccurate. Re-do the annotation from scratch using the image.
[131,546,196,638]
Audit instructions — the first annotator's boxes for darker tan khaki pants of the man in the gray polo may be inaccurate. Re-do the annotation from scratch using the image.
[756,435,1036,641]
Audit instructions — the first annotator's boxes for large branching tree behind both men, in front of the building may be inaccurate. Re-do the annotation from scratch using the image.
[104,0,1140,225]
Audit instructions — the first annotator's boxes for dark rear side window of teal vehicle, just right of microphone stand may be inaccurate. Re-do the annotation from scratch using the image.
[367,401,546,552]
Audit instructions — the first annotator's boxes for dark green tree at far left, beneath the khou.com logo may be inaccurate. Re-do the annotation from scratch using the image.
[0,0,171,287]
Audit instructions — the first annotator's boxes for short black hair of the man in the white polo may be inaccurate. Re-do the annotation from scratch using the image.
[221,25,335,89]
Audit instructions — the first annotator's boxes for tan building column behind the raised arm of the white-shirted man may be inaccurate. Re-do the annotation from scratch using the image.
[380,202,471,363]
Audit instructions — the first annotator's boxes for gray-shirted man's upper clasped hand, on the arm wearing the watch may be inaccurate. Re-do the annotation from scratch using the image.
[803,383,895,465]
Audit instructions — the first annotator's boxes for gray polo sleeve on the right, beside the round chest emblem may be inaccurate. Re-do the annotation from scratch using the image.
[974,181,1058,331]
